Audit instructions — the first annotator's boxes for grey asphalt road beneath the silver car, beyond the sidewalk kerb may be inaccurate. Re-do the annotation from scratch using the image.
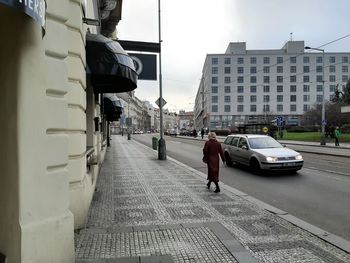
[132,134,350,240]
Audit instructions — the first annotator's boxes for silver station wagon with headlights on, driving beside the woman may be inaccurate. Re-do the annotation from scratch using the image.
[221,134,304,173]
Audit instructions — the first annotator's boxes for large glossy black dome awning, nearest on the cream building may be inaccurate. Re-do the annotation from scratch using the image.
[86,33,137,93]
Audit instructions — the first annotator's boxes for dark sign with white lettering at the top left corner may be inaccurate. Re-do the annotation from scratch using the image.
[0,0,46,28]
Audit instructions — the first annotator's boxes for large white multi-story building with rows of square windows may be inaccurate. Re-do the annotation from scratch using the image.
[194,41,350,130]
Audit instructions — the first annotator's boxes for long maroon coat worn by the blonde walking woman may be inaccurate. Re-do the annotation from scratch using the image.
[203,139,225,183]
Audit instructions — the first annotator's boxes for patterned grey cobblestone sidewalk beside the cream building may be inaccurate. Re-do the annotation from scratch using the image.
[75,136,350,263]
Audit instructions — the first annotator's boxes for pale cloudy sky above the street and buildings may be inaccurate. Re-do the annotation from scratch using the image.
[117,0,350,112]
